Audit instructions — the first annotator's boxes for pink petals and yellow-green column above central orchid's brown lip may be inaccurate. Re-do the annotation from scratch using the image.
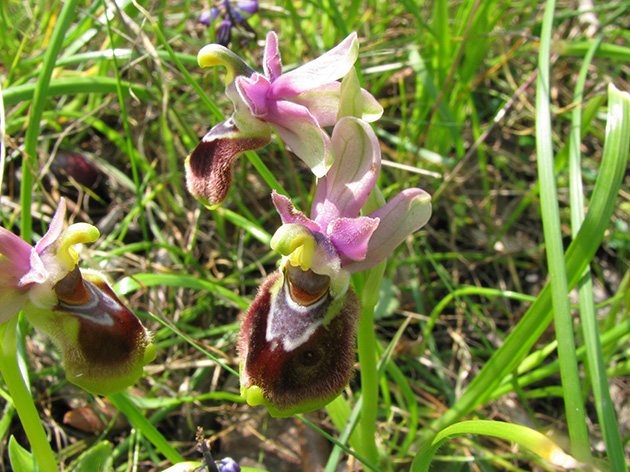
[271,117,431,294]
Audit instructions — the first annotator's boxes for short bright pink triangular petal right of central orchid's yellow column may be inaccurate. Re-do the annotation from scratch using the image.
[326,216,379,262]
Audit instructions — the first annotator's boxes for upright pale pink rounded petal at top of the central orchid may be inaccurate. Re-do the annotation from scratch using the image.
[311,117,381,227]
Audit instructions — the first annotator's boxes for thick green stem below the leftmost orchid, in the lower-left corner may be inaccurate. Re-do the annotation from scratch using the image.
[0,316,58,472]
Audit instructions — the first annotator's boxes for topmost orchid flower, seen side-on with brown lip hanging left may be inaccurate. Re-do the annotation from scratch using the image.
[186,32,383,209]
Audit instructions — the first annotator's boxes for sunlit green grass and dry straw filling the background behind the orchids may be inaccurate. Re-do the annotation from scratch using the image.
[0,0,630,472]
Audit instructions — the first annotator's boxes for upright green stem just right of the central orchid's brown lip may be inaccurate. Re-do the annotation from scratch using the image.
[357,261,386,464]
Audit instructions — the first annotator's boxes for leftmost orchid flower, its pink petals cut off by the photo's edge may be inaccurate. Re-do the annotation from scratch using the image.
[0,199,155,395]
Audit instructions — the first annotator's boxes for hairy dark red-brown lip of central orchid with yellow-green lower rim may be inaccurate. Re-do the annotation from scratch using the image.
[239,270,360,417]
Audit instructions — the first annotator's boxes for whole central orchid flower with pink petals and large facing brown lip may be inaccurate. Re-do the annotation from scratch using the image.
[239,117,431,416]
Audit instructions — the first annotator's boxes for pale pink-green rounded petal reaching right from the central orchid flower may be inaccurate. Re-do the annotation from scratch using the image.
[344,188,431,273]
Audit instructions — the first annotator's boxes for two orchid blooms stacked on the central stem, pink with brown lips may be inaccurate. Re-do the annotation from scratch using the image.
[186,32,431,416]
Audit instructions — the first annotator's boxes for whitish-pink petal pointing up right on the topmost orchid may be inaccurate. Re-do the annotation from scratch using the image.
[270,33,359,99]
